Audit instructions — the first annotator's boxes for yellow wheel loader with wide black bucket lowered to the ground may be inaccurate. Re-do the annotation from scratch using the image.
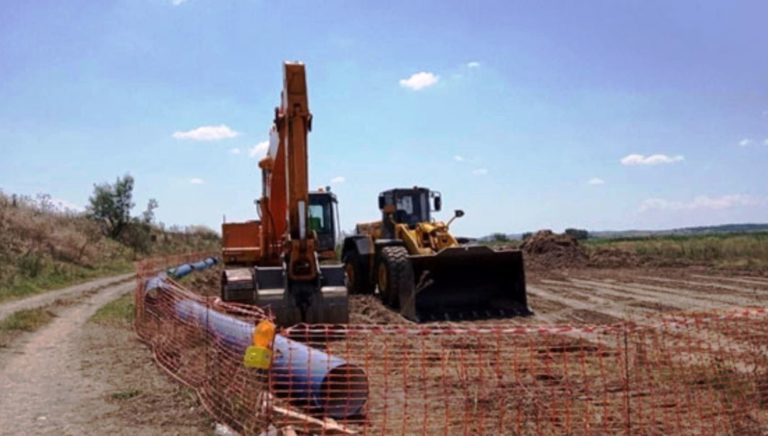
[342,187,531,322]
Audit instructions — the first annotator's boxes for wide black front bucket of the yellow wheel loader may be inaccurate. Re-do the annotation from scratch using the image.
[399,246,532,321]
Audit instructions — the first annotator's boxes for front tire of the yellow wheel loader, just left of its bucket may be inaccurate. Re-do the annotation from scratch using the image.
[377,247,414,309]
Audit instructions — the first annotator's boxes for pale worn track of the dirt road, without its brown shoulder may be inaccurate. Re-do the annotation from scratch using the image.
[0,282,135,434]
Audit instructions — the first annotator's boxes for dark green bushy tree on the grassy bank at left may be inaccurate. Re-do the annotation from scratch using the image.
[88,174,134,239]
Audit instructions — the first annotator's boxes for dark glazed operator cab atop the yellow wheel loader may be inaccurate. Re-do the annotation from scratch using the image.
[379,187,442,239]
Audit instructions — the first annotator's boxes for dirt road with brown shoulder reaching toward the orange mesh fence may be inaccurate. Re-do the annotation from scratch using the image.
[0,276,207,435]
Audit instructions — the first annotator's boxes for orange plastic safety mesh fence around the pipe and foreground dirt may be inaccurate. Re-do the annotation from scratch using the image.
[136,258,768,435]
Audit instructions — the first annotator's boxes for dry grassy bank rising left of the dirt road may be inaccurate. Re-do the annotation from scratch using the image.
[0,192,219,301]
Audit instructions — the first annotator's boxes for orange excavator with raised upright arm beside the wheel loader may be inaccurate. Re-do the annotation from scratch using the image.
[221,62,349,326]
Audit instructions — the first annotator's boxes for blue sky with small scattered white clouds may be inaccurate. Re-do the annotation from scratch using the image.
[0,0,768,236]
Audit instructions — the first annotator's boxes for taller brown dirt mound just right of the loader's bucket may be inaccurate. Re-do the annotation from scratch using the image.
[520,230,589,269]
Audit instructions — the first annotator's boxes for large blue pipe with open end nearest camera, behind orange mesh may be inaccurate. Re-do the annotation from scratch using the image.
[175,300,368,419]
